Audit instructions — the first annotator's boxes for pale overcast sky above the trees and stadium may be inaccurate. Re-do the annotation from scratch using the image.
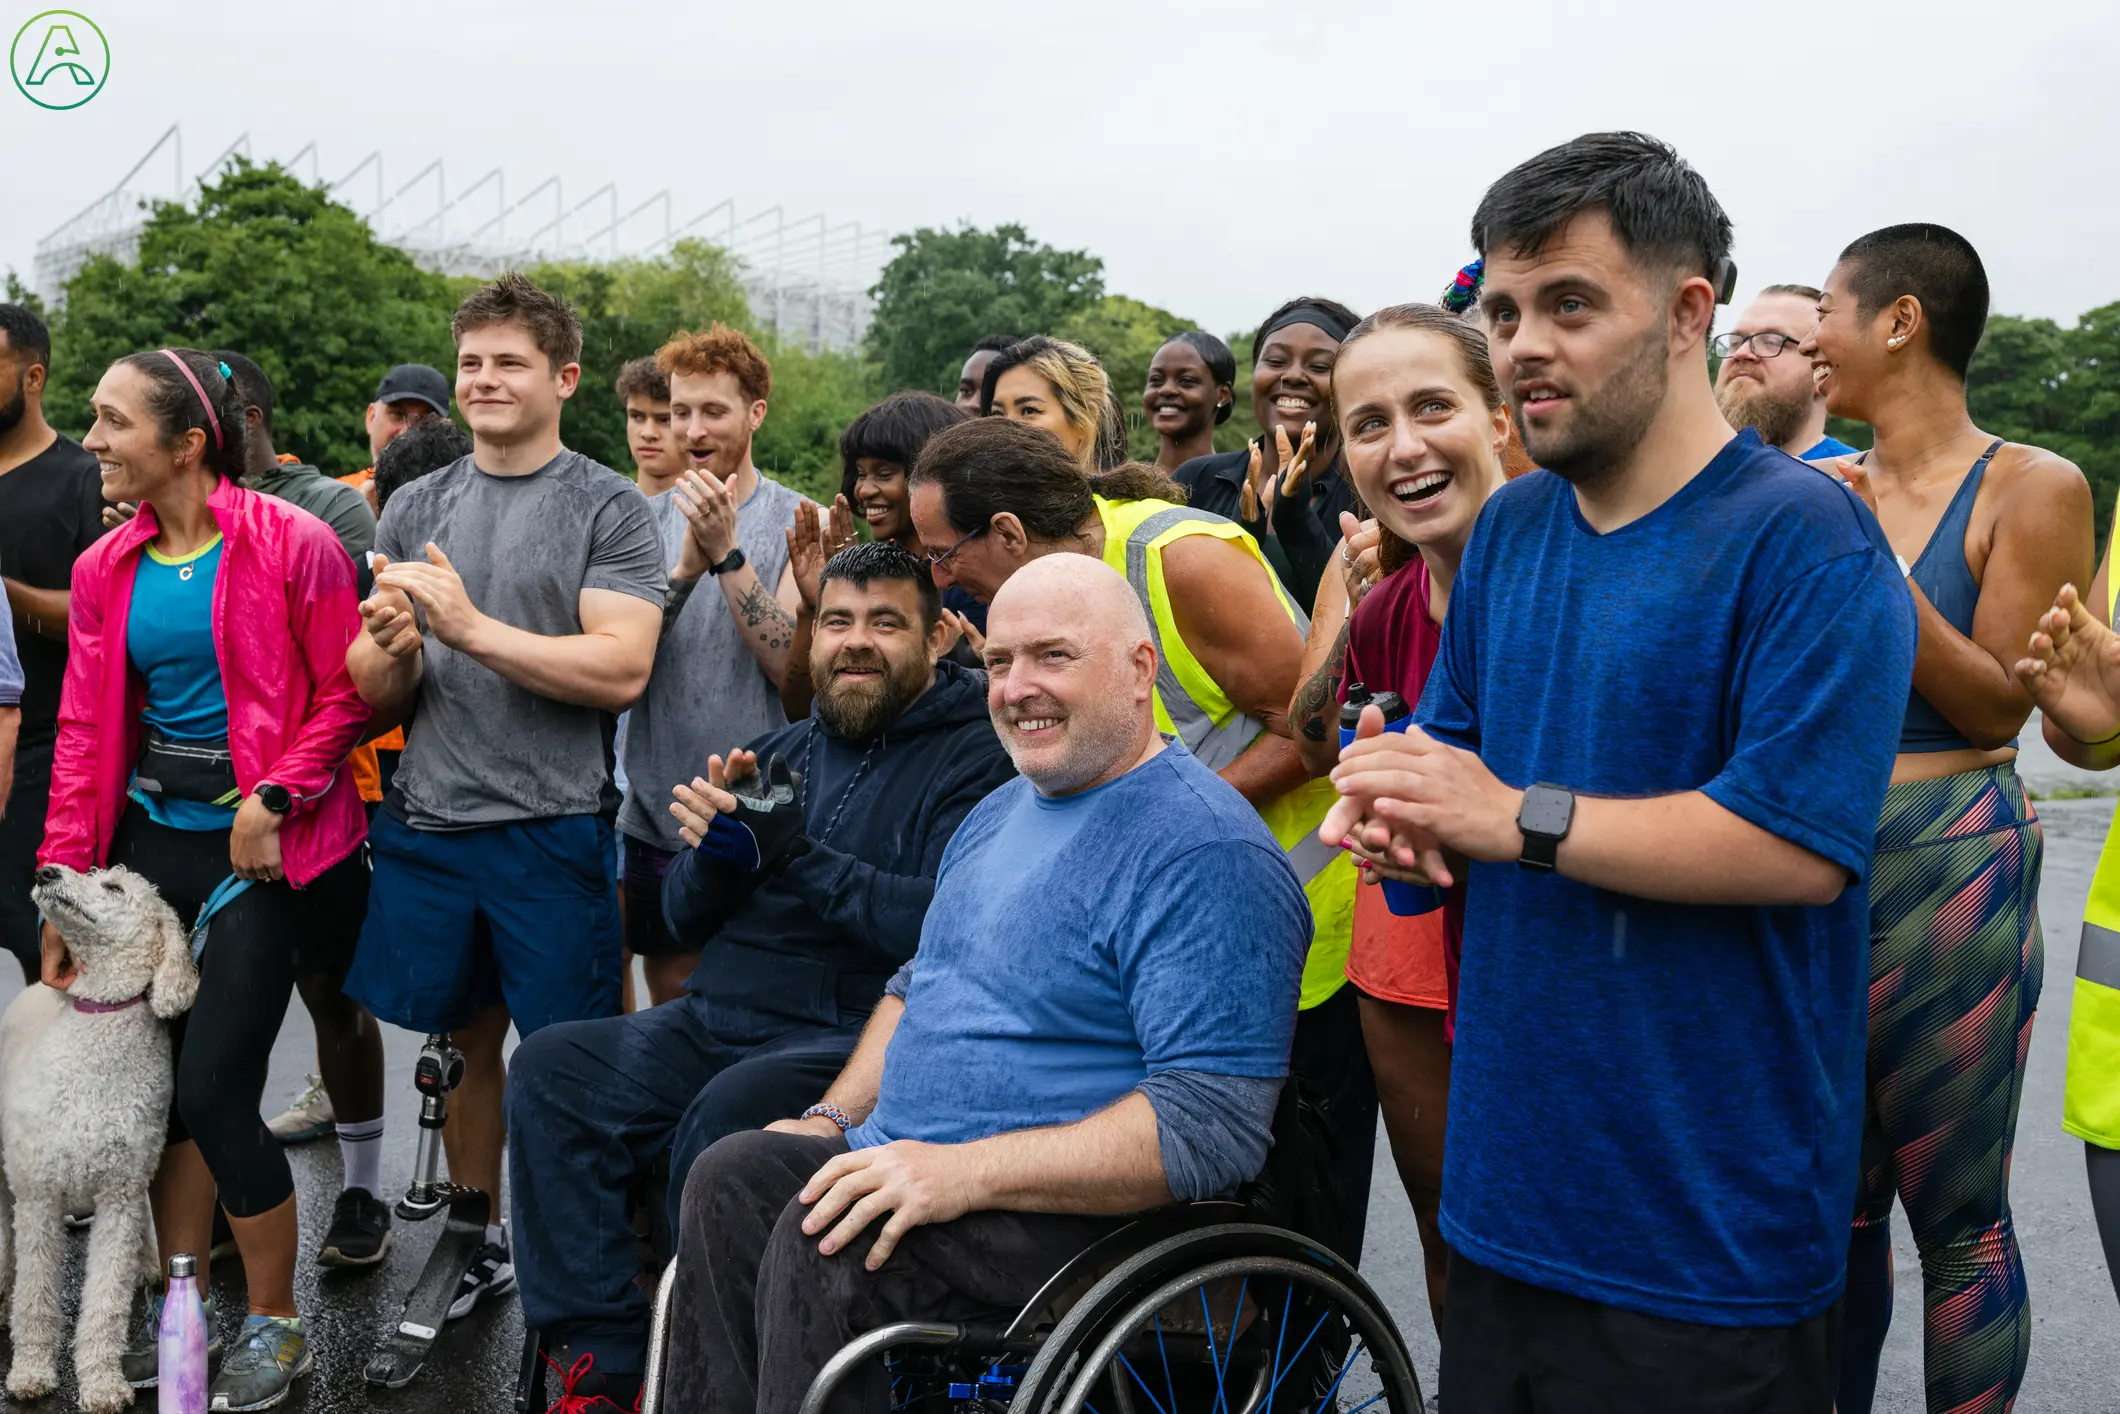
[0,0,2120,331]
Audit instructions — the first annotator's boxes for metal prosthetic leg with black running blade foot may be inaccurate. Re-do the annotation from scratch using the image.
[365,1030,494,1389]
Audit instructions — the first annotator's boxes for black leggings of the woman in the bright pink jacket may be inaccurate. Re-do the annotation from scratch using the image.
[110,801,363,1217]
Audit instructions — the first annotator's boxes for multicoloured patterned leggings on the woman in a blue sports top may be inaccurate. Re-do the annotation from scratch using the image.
[1838,765,2046,1414]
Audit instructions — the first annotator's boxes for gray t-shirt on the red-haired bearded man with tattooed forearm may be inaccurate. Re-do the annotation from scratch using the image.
[619,475,801,850]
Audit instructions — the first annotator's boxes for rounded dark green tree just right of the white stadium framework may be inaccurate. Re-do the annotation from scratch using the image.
[867,225,1105,394]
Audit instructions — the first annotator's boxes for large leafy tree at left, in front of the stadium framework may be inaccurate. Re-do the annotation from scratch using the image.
[45,157,454,475]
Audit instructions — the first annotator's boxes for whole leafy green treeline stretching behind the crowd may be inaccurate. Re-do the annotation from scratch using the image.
[8,159,2120,524]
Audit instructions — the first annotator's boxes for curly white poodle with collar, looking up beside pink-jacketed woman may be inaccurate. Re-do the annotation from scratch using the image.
[0,865,199,1412]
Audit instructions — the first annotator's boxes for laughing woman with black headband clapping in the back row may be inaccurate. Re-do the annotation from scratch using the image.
[1164,295,1361,604]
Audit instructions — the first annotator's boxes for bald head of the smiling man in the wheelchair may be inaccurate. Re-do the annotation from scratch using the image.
[984,553,1164,795]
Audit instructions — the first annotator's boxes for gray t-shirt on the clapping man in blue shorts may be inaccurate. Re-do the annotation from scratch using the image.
[375,452,666,829]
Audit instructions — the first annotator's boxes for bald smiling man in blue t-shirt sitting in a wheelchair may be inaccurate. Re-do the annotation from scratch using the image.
[652,555,1310,1414]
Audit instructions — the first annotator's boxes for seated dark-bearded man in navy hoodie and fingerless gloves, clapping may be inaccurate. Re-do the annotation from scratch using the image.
[507,541,1013,1410]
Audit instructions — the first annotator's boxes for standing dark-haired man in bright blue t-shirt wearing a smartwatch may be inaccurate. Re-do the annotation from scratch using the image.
[1321,134,1914,1414]
